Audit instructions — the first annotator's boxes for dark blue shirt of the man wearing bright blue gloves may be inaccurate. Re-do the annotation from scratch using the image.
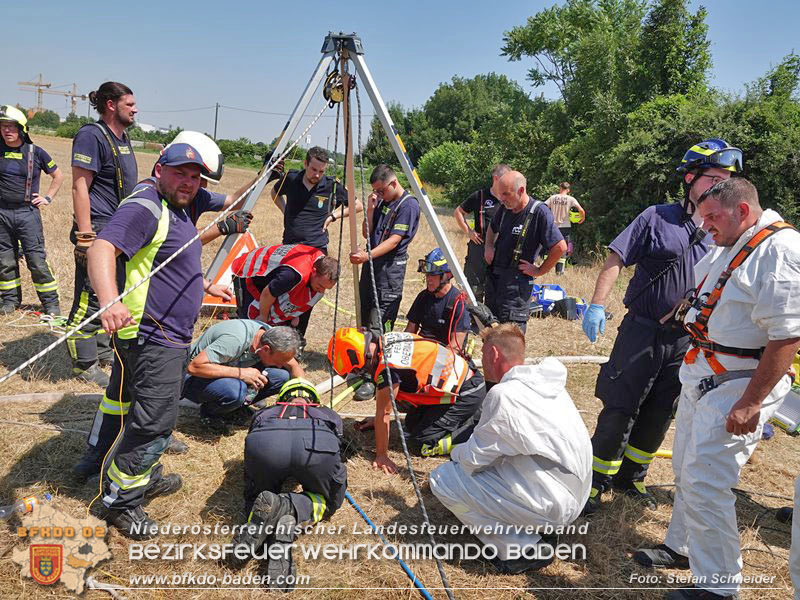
[608,204,708,320]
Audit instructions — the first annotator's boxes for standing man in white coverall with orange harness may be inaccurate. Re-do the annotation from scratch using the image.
[633,177,800,600]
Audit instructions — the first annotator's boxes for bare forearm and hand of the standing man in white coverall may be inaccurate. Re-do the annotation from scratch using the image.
[725,338,800,435]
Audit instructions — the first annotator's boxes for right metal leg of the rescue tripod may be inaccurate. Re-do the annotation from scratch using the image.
[350,52,475,305]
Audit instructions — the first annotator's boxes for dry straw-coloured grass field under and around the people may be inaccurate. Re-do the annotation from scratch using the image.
[0,136,800,600]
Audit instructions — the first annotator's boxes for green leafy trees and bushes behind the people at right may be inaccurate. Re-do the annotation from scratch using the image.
[365,0,800,250]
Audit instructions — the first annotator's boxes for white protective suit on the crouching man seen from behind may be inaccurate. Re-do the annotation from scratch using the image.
[430,358,592,560]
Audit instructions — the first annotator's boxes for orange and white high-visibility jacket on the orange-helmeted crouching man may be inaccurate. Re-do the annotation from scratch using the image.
[375,333,474,406]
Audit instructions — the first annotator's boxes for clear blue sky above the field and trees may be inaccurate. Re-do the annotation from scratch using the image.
[0,0,800,145]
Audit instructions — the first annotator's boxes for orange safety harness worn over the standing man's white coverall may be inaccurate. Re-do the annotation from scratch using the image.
[683,221,794,375]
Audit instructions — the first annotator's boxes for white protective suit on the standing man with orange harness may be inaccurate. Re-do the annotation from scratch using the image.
[665,210,800,596]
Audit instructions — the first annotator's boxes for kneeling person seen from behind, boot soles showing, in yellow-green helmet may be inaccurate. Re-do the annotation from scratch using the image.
[229,379,347,591]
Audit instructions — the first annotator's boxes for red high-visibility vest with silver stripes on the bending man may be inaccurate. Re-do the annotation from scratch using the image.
[232,244,325,325]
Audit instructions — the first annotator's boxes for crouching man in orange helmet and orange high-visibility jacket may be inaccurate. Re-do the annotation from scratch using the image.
[328,327,486,473]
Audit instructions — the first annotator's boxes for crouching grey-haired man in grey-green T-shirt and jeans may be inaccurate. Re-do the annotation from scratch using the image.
[183,319,304,429]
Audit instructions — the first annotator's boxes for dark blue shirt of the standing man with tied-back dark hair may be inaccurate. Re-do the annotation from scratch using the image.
[72,124,139,226]
